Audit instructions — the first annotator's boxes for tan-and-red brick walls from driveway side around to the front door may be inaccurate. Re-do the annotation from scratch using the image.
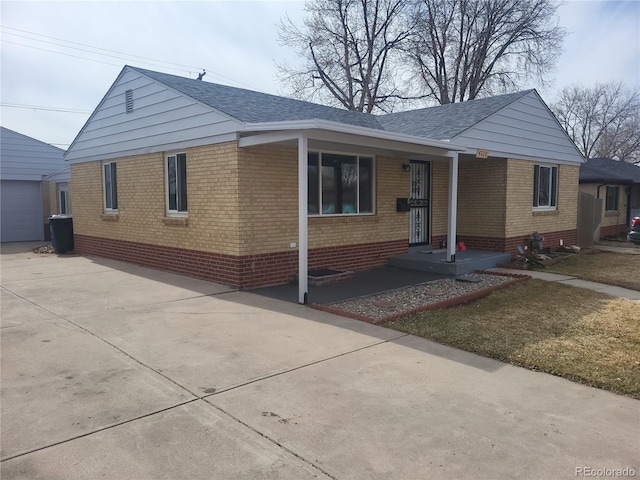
[71,143,409,287]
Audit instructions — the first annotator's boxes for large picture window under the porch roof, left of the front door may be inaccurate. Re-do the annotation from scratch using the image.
[308,152,374,215]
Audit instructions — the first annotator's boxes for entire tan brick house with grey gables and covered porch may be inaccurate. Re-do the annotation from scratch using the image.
[65,66,583,301]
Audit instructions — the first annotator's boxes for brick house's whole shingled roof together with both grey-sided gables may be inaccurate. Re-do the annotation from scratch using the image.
[66,66,582,163]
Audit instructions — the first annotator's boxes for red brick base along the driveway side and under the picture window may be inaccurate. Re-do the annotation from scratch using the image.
[74,234,408,288]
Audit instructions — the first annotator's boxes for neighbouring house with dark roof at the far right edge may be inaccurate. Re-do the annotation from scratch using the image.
[580,158,640,238]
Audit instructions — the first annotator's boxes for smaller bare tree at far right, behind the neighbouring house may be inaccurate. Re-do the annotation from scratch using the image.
[551,82,640,162]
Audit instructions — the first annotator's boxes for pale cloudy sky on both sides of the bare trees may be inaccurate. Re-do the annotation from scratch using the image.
[0,0,640,149]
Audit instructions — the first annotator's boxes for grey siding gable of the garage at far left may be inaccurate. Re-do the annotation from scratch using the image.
[0,127,68,181]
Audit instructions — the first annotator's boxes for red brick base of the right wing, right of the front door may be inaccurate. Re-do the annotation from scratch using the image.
[431,230,577,255]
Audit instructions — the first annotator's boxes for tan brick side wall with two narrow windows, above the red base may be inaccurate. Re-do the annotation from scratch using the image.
[71,143,240,255]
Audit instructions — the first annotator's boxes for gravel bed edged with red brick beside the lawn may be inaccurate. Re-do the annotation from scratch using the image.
[328,273,513,320]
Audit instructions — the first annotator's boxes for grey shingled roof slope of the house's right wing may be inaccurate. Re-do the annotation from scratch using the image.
[378,90,533,140]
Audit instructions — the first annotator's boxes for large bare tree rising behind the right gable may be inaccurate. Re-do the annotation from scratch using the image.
[407,0,565,104]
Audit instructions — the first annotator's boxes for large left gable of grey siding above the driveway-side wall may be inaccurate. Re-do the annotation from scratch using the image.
[66,67,239,163]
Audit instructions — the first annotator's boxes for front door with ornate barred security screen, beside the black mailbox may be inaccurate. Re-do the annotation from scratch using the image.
[409,161,431,245]
